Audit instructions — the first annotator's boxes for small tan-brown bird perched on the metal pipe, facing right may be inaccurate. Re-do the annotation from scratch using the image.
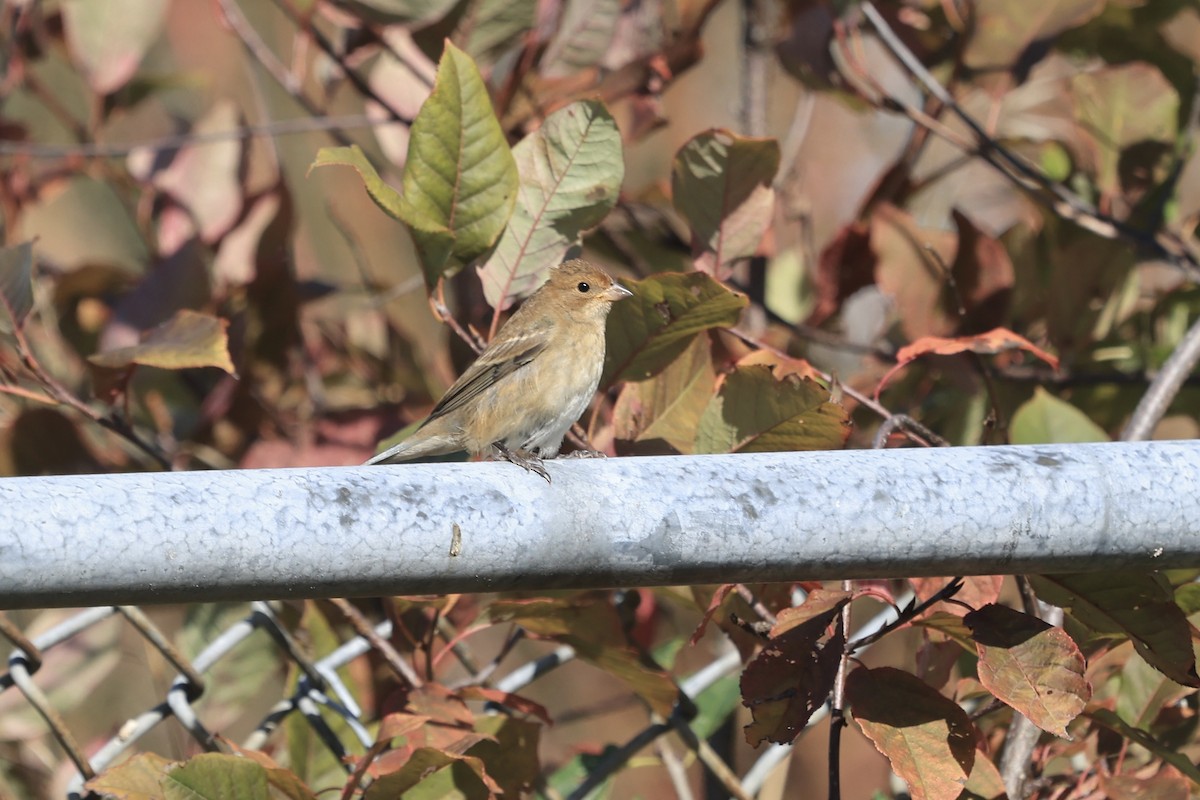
[366,259,632,482]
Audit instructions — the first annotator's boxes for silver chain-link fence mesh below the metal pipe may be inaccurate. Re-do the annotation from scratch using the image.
[0,585,906,800]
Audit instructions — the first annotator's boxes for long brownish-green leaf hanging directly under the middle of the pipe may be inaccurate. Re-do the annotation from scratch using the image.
[488,593,678,716]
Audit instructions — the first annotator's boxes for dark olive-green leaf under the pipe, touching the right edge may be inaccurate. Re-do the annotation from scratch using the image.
[1030,572,1200,686]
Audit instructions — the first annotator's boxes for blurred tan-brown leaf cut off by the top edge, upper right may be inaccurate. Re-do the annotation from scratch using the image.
[962,0,1104,70]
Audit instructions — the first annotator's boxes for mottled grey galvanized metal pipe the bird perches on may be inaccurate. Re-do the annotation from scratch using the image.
[0,441,1200,608]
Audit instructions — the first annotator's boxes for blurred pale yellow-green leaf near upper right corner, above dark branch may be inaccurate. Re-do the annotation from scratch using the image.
[1070,62,1180,196]
